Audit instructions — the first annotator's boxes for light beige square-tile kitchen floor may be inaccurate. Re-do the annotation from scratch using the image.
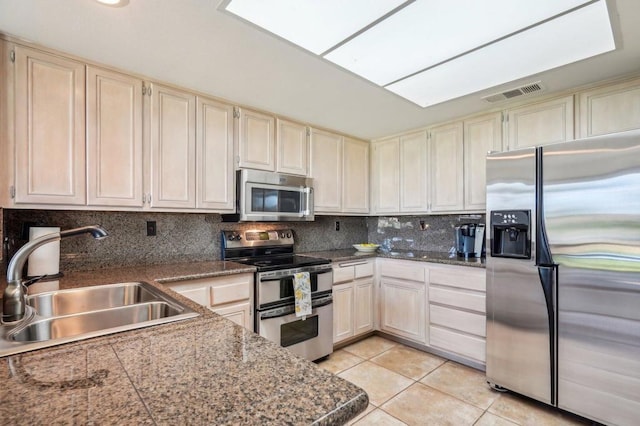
[319,336,591,426]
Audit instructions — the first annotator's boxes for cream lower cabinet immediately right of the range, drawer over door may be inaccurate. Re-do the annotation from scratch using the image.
[333,259,375,344]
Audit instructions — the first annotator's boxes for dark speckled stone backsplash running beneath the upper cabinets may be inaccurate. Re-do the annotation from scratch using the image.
[0,209,484,271]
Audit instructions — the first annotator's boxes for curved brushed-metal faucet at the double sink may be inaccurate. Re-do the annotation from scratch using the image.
[2,225,108,323]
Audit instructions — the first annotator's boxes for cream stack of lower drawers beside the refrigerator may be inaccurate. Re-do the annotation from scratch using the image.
[429,265,486,364]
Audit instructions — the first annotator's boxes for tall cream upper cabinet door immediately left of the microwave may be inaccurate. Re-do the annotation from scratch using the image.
[196,97,235,211]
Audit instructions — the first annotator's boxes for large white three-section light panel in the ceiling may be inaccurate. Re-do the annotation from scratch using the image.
[226,0,615,107]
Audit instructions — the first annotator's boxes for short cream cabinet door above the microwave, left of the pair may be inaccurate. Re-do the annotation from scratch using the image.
[238,109,276,172]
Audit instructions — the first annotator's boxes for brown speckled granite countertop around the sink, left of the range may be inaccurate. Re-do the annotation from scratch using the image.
[0,262,368,425]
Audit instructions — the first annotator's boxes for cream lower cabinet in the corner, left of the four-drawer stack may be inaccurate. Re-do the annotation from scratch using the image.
[378,259,428,344]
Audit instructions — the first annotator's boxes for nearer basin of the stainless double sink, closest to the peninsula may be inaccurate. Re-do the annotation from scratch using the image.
[10,302,181,342]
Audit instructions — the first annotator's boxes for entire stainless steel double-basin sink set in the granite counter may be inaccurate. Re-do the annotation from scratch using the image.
[0,282,199,356]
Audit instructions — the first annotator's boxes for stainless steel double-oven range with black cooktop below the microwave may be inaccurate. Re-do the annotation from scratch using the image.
[222,229,333,360]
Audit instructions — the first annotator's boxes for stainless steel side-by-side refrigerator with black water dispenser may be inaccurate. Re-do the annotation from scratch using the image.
[486,131,640,425]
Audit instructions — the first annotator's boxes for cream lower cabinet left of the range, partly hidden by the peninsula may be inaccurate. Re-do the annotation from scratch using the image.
[167,274,253,331]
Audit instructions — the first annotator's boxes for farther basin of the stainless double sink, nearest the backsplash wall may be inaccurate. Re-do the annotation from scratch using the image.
[27,282,160,317]
